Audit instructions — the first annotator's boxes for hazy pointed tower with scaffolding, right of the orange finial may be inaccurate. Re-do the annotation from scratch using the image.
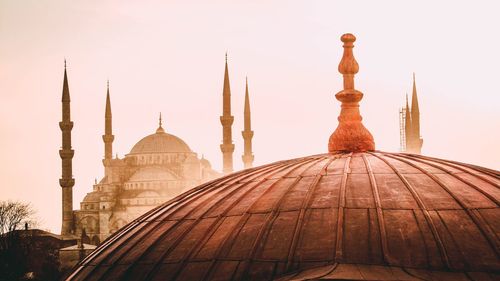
[400,73,424,154]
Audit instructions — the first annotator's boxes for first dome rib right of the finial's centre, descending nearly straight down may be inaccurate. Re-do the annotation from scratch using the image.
[362,154,395,264]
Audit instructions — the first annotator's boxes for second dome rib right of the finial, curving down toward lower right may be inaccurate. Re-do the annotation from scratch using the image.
[367,152,452,268]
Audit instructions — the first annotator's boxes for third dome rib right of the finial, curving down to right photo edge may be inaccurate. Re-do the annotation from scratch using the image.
[383,153,500,258]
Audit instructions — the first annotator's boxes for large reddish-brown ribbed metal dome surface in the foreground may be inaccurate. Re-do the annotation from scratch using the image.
[69,151,500,280]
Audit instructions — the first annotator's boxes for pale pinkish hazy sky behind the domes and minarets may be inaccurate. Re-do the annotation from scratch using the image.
[0,0,500,232]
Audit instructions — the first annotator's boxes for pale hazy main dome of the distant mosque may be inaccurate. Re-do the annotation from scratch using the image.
[130,131,191,154]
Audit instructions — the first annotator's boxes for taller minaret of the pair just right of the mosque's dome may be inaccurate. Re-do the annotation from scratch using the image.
[220,53,234,174]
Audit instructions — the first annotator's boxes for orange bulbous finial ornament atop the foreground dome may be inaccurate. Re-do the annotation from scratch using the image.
[328,33,375,152]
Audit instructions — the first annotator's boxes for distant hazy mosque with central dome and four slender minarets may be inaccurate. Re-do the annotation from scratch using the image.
[59,54,254,245]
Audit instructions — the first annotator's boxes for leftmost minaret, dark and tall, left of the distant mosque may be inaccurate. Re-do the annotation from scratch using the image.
[59,60,75,236]
